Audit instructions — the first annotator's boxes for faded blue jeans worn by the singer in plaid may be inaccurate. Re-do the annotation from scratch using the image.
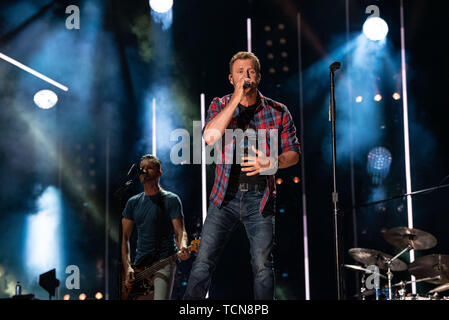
[184,191,275,300]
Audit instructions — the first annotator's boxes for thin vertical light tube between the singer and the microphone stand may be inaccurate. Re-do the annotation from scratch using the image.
[297,12,310,300]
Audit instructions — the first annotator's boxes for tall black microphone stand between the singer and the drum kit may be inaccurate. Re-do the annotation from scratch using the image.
[329,62,343,300]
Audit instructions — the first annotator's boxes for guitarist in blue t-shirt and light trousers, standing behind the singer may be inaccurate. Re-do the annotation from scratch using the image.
[121,155,190,300]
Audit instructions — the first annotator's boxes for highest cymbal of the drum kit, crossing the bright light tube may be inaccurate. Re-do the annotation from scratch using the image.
[384,227,437,250]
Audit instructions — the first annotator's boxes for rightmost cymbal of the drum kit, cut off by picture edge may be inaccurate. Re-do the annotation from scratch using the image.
[408,254,449,284]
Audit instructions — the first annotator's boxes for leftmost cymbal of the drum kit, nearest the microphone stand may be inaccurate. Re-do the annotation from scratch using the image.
[349,248,407,271]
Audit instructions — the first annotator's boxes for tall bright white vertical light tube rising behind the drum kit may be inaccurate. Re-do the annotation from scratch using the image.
[401,0,416,294]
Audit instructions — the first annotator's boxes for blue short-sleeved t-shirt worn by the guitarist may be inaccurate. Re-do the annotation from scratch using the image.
[122,189,183,264]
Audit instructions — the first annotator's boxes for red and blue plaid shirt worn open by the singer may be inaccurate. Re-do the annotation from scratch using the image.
[203,92,300,213]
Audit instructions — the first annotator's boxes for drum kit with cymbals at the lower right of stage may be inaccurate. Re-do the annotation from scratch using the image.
[343,227,449,300]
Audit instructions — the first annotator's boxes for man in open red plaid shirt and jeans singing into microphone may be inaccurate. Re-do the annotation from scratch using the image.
[184,52,300,300]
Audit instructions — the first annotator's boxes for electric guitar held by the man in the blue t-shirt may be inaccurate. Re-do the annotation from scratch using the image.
[122,240,200,300]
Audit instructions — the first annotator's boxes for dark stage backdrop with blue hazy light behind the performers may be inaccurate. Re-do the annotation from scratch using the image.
[0,0,449,300]
